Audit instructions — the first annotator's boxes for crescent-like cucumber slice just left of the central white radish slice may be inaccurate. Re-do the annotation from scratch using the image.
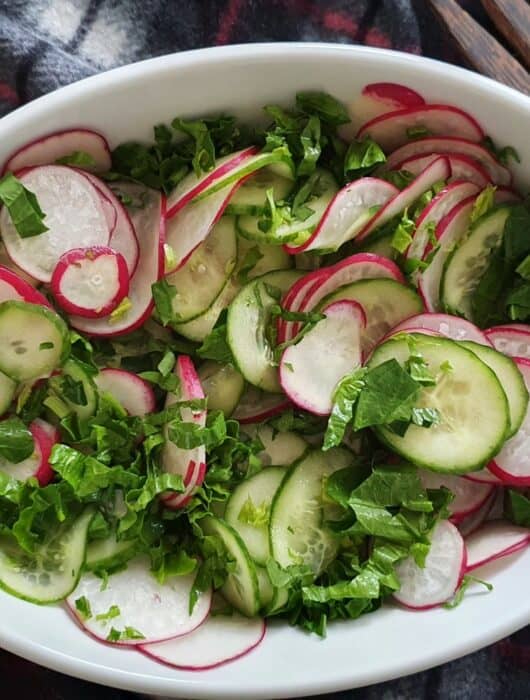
[226,270,302,393]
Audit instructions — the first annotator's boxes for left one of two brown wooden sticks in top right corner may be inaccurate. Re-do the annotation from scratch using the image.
[429,0,530,95]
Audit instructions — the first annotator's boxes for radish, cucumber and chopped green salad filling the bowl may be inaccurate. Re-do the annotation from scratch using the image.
[0,83,530,670]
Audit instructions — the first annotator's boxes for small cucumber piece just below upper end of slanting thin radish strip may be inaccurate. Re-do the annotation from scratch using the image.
[225,168,293,216]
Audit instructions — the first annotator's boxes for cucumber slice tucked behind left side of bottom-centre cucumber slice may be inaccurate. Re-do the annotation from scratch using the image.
[225,467,285,566]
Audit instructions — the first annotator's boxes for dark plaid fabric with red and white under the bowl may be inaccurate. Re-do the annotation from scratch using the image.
[0,0,530,700]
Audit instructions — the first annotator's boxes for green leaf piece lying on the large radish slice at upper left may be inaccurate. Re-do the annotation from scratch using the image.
[0,173,48,238]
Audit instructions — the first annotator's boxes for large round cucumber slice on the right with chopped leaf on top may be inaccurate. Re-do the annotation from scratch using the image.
[368,334,510,474]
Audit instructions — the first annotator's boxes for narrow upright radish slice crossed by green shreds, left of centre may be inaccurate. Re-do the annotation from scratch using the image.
[161,355,206,508]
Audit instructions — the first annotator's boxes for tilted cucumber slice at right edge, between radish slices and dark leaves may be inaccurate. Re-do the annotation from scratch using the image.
[440,206,510,321]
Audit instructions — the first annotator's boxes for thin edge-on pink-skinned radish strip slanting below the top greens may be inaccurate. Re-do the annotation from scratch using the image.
[167,146,259,218]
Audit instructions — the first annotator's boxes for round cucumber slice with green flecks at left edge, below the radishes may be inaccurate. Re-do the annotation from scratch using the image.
[0,300,70,382]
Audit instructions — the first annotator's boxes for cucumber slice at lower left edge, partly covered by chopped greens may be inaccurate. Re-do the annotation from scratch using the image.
[0,508,94,605]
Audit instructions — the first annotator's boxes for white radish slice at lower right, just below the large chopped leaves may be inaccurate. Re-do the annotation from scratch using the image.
[394,520,466,610]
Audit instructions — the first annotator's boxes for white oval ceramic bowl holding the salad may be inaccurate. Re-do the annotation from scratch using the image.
[0,44,530,700]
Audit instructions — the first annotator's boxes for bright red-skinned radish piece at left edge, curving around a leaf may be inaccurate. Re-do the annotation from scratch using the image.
[0,418,58,486]
